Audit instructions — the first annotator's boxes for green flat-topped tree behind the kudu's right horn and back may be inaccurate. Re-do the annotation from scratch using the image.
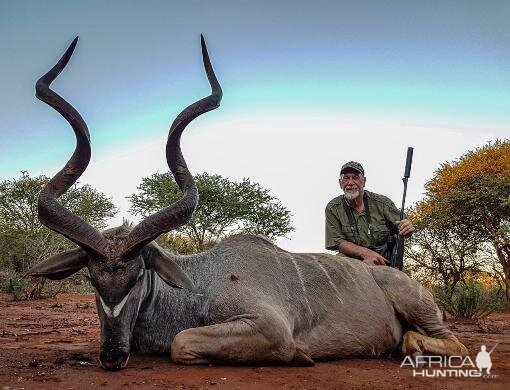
[129,173,294,252]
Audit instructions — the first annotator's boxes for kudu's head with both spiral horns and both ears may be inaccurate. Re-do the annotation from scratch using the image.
[25,36,222,370]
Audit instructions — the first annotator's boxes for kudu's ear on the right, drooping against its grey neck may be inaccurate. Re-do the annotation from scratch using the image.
[142,243,197,292]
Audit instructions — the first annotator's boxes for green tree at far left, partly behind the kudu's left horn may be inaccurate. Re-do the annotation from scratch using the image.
[0,172,116,274]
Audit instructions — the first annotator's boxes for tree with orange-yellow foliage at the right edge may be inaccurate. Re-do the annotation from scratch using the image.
[416,140,510,304]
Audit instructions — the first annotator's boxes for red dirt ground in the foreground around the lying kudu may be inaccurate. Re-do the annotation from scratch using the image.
[0,294,510,390]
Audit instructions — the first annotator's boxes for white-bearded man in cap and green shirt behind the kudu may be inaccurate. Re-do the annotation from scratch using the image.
[326,161,414,265]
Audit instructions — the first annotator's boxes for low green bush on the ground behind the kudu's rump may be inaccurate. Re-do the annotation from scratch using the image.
[432,280,505,319]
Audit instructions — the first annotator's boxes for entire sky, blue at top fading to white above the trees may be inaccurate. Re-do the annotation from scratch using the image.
[0,0,510,251]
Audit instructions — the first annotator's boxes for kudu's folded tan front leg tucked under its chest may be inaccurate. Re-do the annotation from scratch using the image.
[171,318,314,366]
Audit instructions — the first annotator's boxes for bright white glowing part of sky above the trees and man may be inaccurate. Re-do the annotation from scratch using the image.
[80,114,491,252]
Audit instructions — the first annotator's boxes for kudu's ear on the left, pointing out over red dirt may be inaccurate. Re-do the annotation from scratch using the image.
[22,248,89,280]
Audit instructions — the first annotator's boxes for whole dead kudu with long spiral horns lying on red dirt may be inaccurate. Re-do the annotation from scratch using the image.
[26,37,467,370]
